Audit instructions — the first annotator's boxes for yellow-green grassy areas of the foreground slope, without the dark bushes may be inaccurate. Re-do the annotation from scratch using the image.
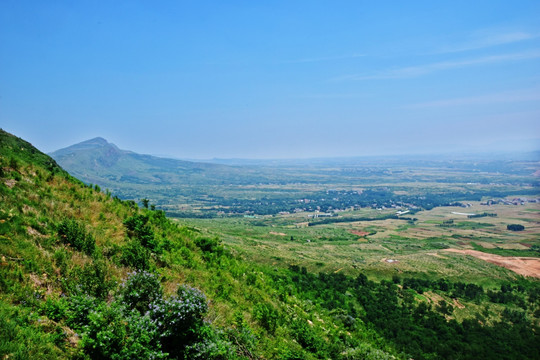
[0,130,395,359]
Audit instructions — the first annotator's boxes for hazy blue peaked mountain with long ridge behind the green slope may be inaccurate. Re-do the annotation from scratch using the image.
[49,137,258,198]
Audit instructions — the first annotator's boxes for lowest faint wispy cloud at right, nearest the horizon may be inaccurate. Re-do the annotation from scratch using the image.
[405,88,540,109]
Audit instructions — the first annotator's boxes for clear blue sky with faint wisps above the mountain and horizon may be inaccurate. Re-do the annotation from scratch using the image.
[0,0,540,158]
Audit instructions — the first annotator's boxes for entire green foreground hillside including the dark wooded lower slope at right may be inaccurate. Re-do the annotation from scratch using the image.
[0,130,540,359]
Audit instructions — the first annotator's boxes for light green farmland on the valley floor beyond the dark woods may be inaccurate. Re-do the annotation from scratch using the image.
[178,198,540,285]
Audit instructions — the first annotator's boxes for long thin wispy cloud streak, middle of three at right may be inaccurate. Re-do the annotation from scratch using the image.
[332,50,540,81]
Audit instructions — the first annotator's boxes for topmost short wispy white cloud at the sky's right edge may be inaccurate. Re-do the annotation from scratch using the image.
[436,31,540,53]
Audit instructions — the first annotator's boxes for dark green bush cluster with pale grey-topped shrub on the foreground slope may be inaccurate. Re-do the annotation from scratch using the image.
[66,271,234,360]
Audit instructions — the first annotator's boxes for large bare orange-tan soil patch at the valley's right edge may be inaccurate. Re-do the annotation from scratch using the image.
[443,249,540,278]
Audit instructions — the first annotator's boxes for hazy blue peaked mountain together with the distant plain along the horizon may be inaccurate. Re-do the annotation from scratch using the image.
[50,137,539,213]
